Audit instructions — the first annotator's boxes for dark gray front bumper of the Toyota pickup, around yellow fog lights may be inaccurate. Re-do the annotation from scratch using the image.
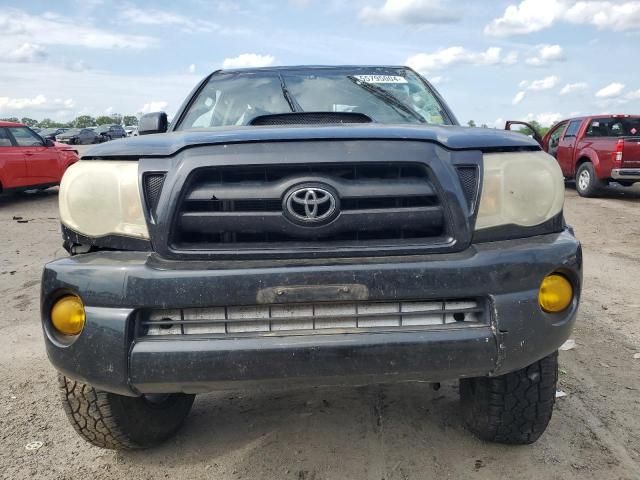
[42,231,582,395]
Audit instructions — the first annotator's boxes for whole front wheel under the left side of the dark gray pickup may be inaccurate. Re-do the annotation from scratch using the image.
[58,375,195,450]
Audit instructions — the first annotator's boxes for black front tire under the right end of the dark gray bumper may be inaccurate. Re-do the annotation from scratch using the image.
[460,352,558,445]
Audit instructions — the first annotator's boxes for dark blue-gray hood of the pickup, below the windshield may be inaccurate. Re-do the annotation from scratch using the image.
[82,124,540,160]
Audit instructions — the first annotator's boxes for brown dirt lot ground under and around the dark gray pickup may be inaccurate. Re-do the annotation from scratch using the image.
[0,169,640,480]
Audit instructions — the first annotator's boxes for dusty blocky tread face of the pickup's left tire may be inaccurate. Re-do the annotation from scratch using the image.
[58,375,142,450]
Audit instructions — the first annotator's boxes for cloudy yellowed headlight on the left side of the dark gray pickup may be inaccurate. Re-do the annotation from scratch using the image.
[59,160,149,239]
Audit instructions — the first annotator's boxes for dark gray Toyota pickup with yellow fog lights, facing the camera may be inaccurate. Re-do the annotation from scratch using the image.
[42,66,582,448]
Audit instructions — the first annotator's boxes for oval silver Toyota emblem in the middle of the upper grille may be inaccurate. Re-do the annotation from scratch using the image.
[284,185,338,225]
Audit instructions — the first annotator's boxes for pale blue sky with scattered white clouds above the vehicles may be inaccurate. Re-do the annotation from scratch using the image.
[0,0,640,126]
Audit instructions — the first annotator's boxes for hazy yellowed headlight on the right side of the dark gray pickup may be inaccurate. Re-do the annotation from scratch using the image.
[476,152,564,230]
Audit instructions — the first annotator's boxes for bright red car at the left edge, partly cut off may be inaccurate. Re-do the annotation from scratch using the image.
[0,122,79,192]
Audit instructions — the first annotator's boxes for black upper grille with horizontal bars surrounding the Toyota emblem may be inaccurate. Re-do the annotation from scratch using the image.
[171,162,446,251]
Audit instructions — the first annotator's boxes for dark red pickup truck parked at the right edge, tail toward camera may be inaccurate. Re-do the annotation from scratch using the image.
[505,115,640,197]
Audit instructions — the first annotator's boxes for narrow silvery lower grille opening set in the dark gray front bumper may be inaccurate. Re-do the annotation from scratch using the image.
[138,300,486,337]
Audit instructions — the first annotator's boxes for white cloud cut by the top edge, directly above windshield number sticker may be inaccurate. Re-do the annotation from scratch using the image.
[360,0,460,25]
